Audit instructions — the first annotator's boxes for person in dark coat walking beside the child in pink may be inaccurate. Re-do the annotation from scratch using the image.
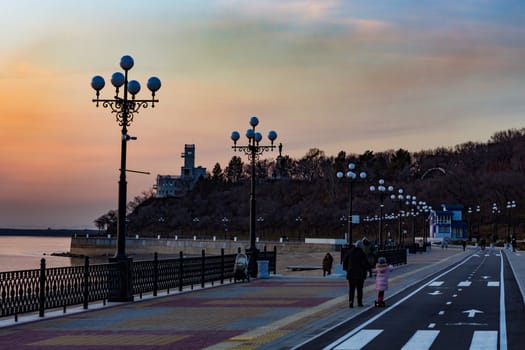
[343,241,370,307]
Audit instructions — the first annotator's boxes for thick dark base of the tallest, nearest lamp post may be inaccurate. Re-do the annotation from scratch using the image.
[108,256,133,302]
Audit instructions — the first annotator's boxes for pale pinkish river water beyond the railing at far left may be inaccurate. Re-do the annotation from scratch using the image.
[0,236,77,272]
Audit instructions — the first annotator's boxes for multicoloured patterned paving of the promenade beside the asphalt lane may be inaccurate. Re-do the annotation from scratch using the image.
[0,247,525,350]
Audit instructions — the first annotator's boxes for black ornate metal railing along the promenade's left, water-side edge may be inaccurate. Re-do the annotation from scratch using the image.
[0,248,277,321]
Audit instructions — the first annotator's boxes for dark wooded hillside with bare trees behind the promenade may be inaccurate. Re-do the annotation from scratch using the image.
[96,128,525,240]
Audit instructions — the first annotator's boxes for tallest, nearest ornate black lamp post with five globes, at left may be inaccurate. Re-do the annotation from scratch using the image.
[91,56,161,301]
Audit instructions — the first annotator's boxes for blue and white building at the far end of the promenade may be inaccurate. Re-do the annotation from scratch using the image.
[429,204,468,240]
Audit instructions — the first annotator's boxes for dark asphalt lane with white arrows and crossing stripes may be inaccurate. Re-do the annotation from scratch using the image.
[298,249,525,350]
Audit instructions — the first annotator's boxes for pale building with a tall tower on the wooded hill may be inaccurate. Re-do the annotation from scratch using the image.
[155,145,206,198]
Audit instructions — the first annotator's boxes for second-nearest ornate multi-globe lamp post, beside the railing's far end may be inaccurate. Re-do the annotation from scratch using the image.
[231,116,277,277]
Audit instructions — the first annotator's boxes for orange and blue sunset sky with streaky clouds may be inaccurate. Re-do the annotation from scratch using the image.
[0,0,525,228]
